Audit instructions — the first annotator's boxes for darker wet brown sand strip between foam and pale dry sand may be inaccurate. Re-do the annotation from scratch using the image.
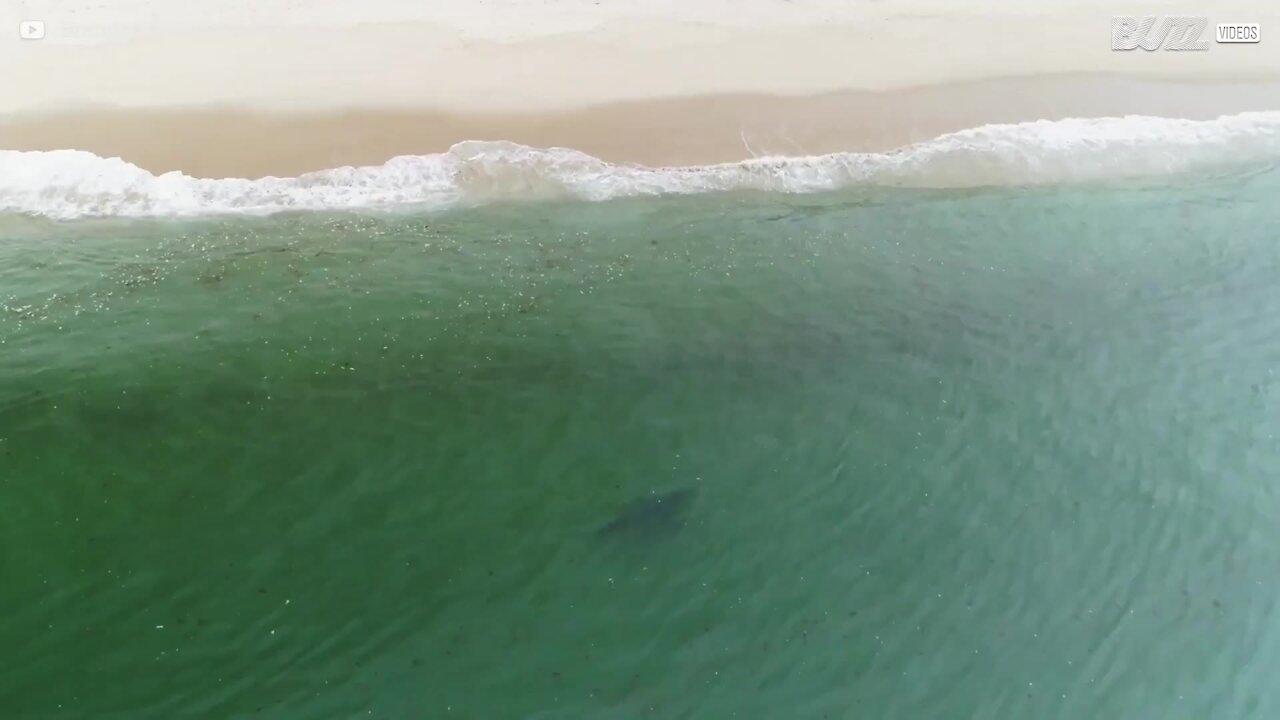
[0,74,1280,178]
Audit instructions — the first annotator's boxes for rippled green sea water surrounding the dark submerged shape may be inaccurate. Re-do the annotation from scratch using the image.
[0,165,1280,720]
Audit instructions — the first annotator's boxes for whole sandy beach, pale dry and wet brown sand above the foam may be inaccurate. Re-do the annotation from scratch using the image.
[0,0,1280,177]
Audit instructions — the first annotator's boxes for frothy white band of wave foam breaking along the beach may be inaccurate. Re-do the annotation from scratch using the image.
[0,113,1280,219]
